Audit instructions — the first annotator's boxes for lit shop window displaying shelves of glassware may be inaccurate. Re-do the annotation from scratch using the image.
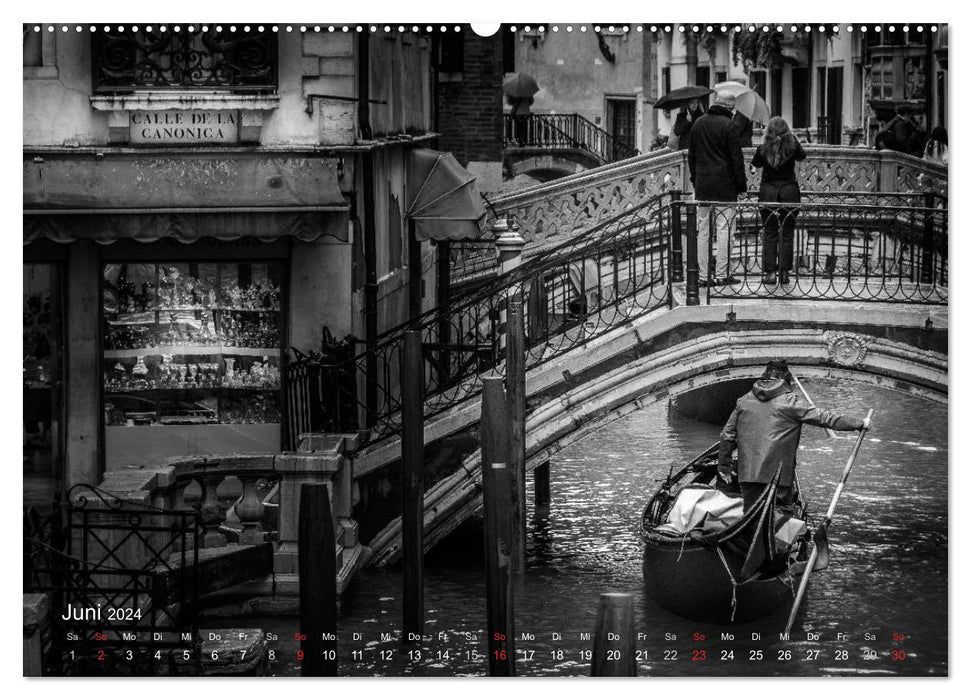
[103,262,285,469]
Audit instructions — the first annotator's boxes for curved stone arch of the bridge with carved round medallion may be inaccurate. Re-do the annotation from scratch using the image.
[370,320,948,565]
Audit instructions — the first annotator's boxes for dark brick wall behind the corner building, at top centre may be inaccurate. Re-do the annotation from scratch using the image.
[438,30,503,165]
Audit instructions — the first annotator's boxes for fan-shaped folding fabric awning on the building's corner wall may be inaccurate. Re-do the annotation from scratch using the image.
[407,148,486,241]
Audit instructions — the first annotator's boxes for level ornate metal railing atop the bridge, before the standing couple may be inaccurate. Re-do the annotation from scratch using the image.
[704,193,948,304]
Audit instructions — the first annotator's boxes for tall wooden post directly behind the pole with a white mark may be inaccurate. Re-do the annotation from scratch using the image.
[506,292,526,574]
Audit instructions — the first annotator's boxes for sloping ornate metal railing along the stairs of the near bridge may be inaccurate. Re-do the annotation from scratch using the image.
[300,197,670,440]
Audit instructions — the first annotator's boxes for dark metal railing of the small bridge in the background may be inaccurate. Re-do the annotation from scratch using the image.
[503,114,639,163]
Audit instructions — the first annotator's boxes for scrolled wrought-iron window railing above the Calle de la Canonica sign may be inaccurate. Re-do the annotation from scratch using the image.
[91,25,277,93]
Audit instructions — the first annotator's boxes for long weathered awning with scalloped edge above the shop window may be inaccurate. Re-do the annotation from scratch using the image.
[24,151,349,245]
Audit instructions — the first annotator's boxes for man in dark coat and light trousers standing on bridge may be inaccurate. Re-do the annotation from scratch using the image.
[688,91,748,284]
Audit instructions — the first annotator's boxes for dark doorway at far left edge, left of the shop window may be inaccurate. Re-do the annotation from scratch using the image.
[23,263,64,505]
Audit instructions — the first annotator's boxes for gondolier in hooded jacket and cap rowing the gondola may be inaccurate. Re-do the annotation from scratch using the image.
[718,360,870,511]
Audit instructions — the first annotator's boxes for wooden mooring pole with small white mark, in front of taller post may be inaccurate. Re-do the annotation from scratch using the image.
[480,377,516,676]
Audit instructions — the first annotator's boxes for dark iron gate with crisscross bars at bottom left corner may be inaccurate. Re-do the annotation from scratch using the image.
[24,484,202,676]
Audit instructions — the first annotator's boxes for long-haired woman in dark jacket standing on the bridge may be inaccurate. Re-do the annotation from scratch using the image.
[752,117,806,285]
